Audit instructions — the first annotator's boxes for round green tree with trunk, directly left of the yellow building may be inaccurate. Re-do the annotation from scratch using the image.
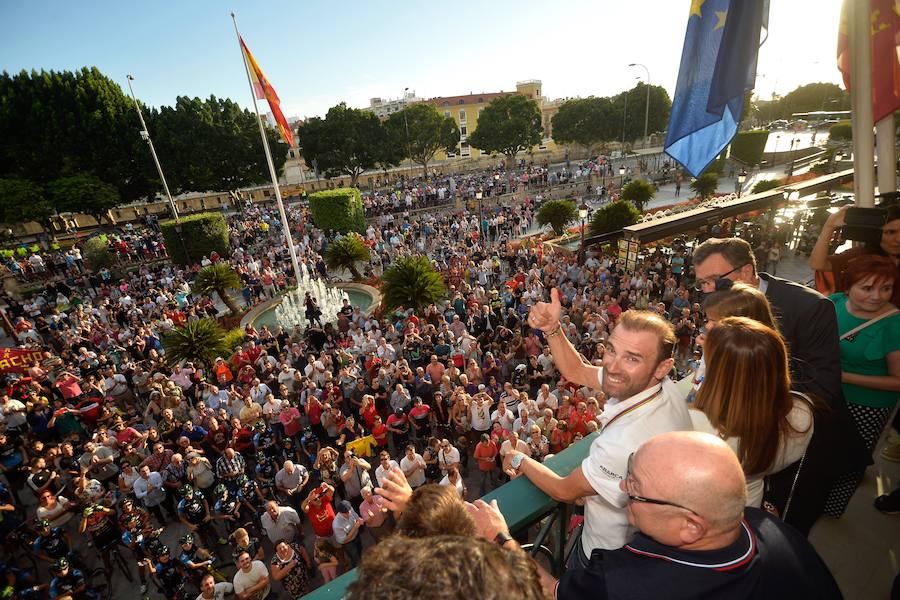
[385,104,459,177]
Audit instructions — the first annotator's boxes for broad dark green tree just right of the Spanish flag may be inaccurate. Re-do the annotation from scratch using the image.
[300,102,390,187]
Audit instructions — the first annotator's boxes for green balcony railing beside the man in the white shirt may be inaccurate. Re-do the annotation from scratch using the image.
[303,433,597,600]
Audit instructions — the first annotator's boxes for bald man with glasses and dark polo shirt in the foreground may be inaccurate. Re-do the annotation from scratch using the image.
[470,431,841,600]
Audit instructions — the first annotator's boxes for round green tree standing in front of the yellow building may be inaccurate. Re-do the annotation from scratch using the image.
[469,94,544,166]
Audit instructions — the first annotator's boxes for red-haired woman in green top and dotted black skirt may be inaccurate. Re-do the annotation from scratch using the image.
[825,254,900,517]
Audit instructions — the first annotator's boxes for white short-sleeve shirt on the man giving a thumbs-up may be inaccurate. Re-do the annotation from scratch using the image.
[581,376,693,557]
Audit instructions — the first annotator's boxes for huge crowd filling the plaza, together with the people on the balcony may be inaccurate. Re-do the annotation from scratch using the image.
[0,173,900,600]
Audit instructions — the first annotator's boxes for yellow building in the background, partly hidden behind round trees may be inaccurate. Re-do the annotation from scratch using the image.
[423,79,559,161]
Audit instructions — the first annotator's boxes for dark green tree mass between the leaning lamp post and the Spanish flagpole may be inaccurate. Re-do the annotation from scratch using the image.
[148,96,287,194]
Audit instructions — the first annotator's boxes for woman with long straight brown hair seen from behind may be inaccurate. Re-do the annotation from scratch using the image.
[690,317,813,507]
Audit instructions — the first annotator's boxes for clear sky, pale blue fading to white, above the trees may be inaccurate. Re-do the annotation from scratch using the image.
[0,0,840,117]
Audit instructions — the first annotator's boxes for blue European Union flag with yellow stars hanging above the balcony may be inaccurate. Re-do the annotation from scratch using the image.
[665,0,768,177]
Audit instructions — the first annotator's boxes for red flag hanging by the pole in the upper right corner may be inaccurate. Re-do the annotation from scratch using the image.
[837,0,900,123]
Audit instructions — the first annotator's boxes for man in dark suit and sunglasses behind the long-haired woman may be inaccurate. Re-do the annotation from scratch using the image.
[693,238,871,535]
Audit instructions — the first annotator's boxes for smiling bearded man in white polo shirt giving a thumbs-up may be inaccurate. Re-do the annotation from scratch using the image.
[504,289,691,567]
